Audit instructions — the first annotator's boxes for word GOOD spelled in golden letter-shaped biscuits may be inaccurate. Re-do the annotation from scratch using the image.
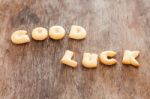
[11,25,86,44]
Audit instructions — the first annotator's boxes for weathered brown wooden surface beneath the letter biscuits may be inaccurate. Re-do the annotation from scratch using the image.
[0,0,150,99]
